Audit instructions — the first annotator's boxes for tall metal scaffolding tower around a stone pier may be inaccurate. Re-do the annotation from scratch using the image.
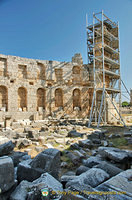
[86,11,125,127]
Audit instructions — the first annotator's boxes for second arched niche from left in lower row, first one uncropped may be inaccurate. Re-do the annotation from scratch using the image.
[18,87,27,111]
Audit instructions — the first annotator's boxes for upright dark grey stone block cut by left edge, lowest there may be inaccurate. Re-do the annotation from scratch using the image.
[0,156,14,193]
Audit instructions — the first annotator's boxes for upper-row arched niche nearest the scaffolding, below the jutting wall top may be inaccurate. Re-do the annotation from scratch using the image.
[72,66,81,84]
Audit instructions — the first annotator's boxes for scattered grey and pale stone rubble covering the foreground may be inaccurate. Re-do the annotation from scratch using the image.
[0,121,132,200]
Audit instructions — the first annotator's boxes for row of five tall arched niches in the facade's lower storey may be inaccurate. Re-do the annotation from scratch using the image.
[0,86,81,111]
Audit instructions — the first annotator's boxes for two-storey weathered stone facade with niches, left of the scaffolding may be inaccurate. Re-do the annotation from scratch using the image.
[0,54,92,121]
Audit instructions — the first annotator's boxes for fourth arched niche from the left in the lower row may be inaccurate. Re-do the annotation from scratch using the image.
[55,88,63,107]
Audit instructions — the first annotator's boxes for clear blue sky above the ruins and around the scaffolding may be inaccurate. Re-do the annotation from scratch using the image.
[0,0,132,100]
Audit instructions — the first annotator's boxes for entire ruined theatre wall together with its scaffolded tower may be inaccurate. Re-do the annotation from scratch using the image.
[0,12,121,126]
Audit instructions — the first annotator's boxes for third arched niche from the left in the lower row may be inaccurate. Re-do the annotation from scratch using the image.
[37,88,45,111]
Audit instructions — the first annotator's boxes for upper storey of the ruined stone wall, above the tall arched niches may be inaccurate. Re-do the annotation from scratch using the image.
[0,54,89,84]
